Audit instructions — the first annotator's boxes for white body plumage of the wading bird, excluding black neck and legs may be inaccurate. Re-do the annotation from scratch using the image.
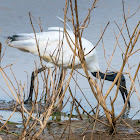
[8,27,99,72]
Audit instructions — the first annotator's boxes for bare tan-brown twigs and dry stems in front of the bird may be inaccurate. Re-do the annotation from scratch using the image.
[0,0,140,139]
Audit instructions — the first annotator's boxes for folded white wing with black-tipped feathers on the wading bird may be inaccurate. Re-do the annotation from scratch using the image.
[8,27,76,66]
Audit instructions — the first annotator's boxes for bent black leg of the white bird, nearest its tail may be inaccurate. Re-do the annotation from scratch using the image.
[24,67,46,104]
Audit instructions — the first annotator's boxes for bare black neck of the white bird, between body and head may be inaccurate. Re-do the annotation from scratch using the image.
[91,71,117,82]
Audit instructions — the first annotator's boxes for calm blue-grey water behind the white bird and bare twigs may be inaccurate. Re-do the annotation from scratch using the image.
[0,0,140,119]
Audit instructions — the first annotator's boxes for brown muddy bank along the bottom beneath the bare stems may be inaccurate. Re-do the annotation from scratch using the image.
[0,118,140,140]
